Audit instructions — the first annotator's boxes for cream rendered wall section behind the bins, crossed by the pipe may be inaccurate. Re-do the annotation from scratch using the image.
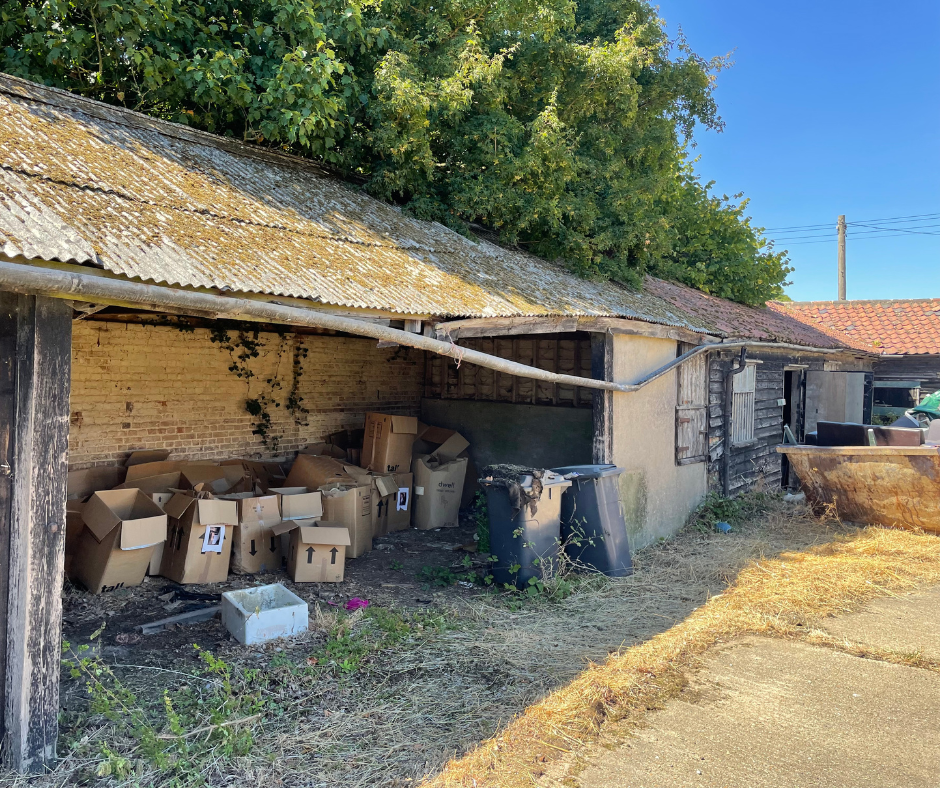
[613,336,706,549]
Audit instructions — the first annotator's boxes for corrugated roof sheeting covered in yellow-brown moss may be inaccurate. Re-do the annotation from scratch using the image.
[0,76,710,331]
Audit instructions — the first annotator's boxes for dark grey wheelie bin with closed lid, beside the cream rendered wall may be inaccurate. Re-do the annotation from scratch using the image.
[552,465,633,577]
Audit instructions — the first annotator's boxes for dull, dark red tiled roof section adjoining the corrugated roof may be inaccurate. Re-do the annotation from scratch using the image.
[643,276,848,348]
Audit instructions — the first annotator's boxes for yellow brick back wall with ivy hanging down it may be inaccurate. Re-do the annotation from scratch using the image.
[69,320,424,469]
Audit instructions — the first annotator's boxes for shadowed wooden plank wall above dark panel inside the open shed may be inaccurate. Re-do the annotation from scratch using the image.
[425,333,593,408]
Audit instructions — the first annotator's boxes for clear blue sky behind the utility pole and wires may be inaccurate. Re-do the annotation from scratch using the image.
[659,0,940,301]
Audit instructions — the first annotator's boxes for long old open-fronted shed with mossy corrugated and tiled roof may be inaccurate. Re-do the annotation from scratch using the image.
[0,77,871,770]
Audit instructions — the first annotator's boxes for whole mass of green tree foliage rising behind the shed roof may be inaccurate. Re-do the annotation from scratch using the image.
[0,0,790,304]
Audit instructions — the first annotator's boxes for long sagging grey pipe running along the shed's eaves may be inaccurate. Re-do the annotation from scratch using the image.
[0,261,845,394]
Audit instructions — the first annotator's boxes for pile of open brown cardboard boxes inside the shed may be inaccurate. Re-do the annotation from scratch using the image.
[66,413,468,593]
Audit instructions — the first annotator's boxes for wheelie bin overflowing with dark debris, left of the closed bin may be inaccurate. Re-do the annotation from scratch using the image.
[480,472,571,588]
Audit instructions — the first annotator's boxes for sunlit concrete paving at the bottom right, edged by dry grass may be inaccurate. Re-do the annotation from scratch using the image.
[576,589,940,788]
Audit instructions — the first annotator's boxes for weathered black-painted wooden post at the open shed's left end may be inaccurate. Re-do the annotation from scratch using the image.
[0,293,72,772]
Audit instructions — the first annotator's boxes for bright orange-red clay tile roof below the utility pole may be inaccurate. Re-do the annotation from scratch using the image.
[769,298,940,355]
